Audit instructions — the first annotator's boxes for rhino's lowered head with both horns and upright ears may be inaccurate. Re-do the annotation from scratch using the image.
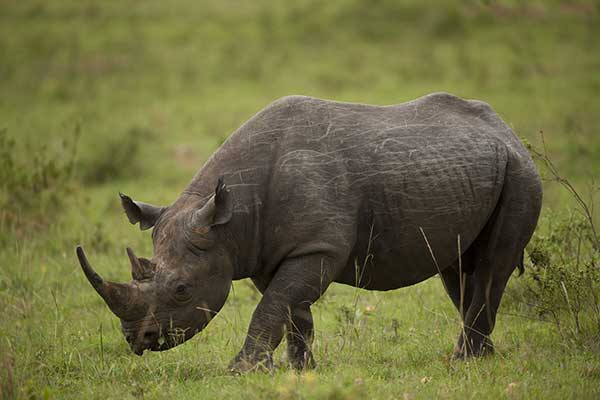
[77,180,234,355]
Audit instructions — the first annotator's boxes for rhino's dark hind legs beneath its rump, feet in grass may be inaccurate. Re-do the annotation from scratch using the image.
[442,155,541,358]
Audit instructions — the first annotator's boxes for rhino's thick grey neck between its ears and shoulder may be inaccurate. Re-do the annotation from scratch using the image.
[182,107,289,279]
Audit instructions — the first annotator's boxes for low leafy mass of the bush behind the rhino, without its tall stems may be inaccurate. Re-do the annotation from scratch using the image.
[524,212,600,350]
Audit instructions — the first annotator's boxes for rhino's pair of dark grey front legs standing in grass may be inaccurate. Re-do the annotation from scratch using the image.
[229,254,344,372]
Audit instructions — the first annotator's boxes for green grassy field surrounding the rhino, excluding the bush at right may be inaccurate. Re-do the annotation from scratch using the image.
[0,0,600,399]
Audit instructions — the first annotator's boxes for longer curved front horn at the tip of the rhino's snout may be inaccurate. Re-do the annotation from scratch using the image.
[77,246,144,321]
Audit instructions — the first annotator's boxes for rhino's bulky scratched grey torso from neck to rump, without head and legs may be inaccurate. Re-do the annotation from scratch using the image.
[186,94,525,289]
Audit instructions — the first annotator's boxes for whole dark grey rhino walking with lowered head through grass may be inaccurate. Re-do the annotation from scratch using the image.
[78,93,542,371]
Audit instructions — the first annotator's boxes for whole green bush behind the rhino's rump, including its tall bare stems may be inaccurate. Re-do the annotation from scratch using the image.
[508,140,600,351]
